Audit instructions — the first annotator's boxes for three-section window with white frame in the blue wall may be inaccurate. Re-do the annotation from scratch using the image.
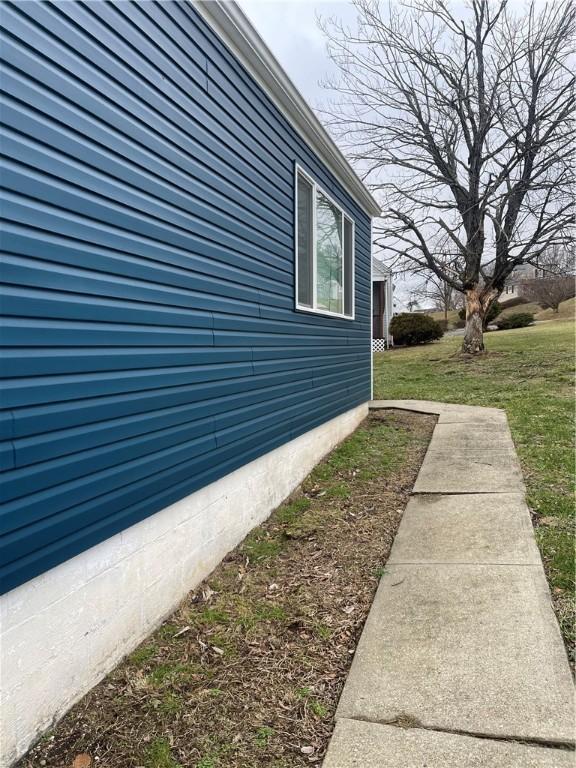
[296,167,354,319]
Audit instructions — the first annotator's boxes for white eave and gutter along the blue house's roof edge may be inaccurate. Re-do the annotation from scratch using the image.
[191,0,381,216]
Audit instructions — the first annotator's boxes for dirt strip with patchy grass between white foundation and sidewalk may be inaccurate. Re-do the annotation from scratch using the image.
[19,410,436,768]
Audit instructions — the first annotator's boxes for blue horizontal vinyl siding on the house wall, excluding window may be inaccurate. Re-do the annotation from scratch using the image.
[0,2,370,591]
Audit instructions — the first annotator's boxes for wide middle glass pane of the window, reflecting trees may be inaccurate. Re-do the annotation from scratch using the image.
[316,191,342,314]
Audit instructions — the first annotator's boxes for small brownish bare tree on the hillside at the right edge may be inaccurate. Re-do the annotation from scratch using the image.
[520,247,576,312]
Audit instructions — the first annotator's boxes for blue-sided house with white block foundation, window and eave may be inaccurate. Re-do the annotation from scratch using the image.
[0,0,379,763]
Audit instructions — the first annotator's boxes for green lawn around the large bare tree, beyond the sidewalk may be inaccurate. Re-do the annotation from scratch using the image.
[374,321,575,646]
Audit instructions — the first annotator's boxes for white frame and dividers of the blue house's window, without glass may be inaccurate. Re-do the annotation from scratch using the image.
[294,163,356,320]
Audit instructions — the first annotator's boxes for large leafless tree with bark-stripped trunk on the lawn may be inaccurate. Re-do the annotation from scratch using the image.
[322,0,575,354]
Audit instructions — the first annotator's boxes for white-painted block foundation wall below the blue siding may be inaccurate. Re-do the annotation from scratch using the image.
[0,405,368,765]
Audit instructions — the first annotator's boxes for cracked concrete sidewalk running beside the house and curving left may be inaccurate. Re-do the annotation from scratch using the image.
[324,400,575,768]
